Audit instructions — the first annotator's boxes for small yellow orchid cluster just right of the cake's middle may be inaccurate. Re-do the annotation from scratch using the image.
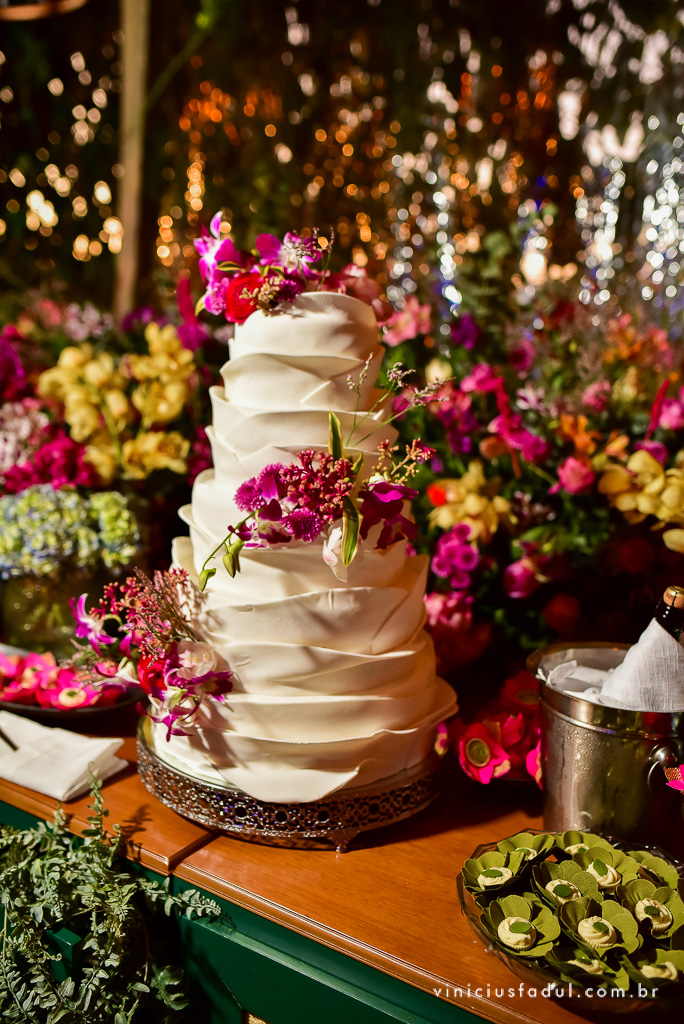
[430,459,510,544]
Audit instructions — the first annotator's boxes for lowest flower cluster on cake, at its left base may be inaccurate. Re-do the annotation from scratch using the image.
[71,568,231,738]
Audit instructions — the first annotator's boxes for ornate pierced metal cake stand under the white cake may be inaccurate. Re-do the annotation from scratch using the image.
[138,720,442,852]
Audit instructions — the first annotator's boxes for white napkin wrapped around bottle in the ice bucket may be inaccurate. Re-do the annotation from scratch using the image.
[601,620,684,712]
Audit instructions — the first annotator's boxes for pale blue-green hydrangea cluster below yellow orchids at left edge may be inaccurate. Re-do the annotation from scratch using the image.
[0,483,140,580]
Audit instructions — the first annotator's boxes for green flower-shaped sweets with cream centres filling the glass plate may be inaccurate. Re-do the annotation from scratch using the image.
[459,831,684,1005]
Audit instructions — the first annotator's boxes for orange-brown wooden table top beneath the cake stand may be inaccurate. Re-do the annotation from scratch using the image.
[0,720,664,1024]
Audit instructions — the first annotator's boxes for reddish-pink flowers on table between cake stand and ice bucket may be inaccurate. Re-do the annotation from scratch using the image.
[452,672,542,788]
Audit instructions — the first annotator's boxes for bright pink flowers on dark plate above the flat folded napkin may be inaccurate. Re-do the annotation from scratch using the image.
[0,654,125,711]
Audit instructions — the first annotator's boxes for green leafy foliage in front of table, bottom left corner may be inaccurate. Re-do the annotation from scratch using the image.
[0,778,220,1024]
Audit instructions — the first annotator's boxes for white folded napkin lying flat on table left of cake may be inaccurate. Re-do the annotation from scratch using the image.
[0,711,128,800]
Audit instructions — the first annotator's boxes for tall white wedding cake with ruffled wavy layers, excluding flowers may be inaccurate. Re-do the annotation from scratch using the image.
[152,292,456,803]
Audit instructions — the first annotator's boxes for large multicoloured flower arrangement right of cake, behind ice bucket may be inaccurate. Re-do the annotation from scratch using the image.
[386,292,684,690]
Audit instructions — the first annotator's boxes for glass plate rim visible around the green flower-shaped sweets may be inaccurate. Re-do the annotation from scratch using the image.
[457,828,684,1014]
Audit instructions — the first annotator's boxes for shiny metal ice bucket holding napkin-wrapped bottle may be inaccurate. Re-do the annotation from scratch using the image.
[527,643,684,855]
